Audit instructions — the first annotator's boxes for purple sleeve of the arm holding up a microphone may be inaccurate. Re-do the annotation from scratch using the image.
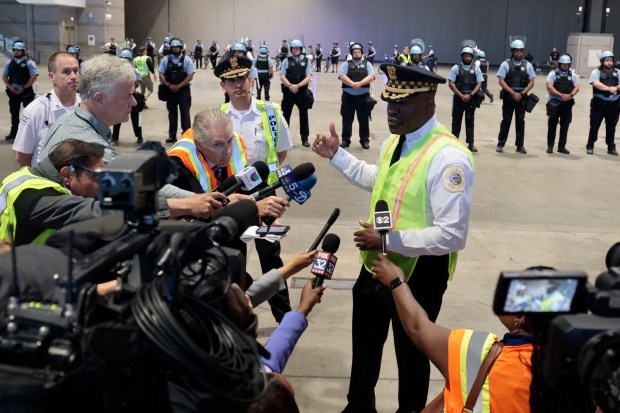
[261,310,308,373]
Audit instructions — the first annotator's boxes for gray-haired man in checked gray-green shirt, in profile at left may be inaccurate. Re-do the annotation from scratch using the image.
[39,54,224,218]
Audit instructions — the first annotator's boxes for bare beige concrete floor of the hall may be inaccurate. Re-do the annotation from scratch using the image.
[0,59,620,413]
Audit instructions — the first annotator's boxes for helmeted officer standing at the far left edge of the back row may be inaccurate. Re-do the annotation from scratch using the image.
[2,40,39,140]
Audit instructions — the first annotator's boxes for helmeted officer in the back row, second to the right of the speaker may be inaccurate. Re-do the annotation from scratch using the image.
[495,40,536,155]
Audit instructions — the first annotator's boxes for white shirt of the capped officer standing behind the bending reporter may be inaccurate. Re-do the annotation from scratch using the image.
[220,97,293,165]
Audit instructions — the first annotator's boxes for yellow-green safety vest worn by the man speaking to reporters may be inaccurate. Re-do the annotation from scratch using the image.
[360,125,474,280]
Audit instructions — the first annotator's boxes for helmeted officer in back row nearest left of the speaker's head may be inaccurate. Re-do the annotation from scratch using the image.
[338,42,375,149]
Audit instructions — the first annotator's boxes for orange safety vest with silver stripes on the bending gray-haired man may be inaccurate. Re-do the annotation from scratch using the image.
[168,128,248,193]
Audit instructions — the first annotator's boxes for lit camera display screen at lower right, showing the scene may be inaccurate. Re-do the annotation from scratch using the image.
[504,278,579,313]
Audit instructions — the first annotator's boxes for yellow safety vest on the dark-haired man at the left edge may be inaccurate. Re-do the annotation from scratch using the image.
[0,166,70,244]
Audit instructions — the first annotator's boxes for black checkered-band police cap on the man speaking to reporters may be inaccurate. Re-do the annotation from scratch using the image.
[380,63,446,102]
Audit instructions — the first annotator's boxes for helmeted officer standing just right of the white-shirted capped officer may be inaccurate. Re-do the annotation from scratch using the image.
[280,39,312,147]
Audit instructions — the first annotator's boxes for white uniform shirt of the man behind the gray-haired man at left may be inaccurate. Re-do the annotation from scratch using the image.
[12,89,80,166]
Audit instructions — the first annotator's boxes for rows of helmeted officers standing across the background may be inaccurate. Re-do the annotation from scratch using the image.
[3,36,620,156]
